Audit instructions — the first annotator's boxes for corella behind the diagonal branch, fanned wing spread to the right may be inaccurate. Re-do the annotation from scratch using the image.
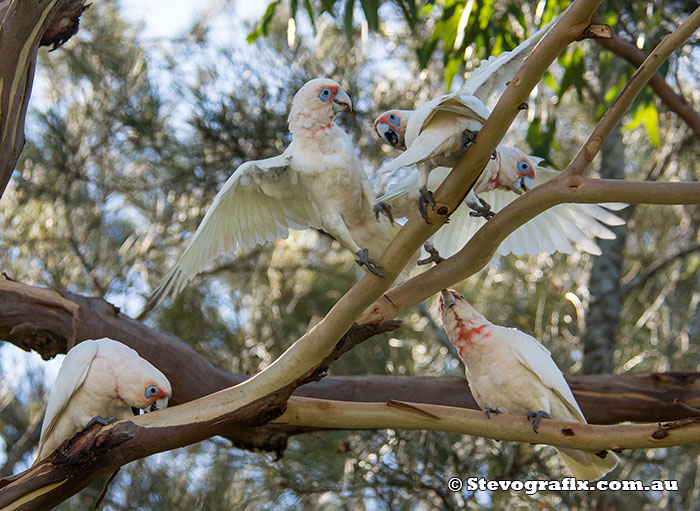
[379,145,626,257]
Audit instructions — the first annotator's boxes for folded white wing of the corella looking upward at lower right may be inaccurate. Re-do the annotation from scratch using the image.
[495,326,586,423]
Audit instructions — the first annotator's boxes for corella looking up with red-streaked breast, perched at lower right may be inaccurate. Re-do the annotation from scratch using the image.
[439,290,618,480]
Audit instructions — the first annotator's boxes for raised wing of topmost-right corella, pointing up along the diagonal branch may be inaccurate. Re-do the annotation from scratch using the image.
[460,14,561,107]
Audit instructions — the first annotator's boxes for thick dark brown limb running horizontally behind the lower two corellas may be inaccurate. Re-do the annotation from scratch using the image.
[0,279,700,426]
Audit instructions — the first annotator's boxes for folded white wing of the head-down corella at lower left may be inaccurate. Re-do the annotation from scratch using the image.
[38,341,97,453]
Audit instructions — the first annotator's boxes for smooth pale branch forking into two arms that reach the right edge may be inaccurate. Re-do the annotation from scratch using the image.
[358,8,700,323]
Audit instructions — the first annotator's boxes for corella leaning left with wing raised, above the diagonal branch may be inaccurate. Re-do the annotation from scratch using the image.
[374,12,556,222]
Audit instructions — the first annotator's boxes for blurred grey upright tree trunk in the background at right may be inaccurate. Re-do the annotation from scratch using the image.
[583,126,630,374]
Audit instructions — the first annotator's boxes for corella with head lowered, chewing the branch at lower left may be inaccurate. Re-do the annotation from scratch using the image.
[36,337,172,462]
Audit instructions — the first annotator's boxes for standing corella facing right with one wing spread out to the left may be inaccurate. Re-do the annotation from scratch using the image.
[139,78,391,318]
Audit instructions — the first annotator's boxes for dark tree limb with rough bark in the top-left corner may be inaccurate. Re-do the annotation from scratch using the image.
[0,0,86,204]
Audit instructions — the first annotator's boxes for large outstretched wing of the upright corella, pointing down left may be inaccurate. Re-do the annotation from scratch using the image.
[139,154,321,318]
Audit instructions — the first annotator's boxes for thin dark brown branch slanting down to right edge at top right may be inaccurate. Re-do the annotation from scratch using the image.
[593,14,700,141]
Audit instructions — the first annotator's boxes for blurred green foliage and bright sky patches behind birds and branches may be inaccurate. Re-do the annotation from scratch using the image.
[0,0,700,510]
